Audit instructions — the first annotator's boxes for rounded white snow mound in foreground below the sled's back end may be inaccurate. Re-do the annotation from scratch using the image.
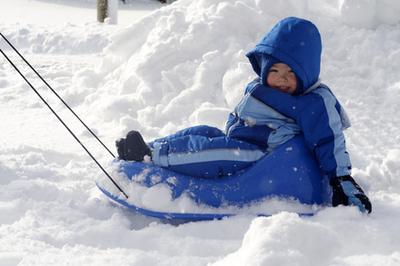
[213,213,339,266]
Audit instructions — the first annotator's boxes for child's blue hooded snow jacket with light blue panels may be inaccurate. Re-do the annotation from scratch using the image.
[226,17,351,177]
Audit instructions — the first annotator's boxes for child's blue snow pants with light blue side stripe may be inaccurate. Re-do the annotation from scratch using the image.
[149,125,265,178]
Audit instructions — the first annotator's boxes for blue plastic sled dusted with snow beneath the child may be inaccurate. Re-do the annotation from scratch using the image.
[98,136,330,220]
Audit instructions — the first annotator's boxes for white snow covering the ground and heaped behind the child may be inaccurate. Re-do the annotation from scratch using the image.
[0,0,400,265]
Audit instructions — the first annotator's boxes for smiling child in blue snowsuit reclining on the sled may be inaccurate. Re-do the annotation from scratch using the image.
[117,17,371,212]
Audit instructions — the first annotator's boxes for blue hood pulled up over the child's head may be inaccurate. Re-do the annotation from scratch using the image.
[246,17,322,94]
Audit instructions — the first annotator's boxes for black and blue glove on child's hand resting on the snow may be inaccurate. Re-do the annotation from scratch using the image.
[329,175,372,213]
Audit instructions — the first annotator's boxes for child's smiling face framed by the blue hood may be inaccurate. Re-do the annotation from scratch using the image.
[267,63,297,94]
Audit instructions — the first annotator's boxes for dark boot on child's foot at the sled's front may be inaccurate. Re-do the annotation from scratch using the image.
[115,130,151,162]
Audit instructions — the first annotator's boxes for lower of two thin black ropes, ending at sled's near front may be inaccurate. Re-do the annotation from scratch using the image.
[0,42,128,198]
